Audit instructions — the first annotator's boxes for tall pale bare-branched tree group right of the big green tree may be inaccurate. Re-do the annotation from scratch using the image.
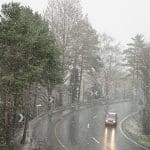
[44,0,103,103]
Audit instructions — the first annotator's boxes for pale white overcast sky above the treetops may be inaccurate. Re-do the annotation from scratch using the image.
[0,0,150,44]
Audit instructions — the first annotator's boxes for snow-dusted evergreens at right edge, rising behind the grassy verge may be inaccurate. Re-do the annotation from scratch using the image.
[125,34,150,135]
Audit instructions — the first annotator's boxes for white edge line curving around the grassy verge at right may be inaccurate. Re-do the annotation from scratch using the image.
[119,112,149,150]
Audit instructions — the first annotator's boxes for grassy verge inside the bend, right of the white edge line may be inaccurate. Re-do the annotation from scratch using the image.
[122,114,150,149]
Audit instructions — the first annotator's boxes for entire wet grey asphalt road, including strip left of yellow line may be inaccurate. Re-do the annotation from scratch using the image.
[33,102,143,150]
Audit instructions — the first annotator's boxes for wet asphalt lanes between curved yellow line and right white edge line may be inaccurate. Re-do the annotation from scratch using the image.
[56,102,143,150]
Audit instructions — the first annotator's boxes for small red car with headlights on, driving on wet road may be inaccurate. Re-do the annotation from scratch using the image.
[105,112,117,126]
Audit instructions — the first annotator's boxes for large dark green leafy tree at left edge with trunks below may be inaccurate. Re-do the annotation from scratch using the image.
[0,3,63,149]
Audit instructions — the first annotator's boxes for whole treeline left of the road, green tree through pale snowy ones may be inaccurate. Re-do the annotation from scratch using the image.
[0,0,137,149]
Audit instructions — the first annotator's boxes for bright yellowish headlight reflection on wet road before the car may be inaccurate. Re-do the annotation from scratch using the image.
[103,127,116,150]
